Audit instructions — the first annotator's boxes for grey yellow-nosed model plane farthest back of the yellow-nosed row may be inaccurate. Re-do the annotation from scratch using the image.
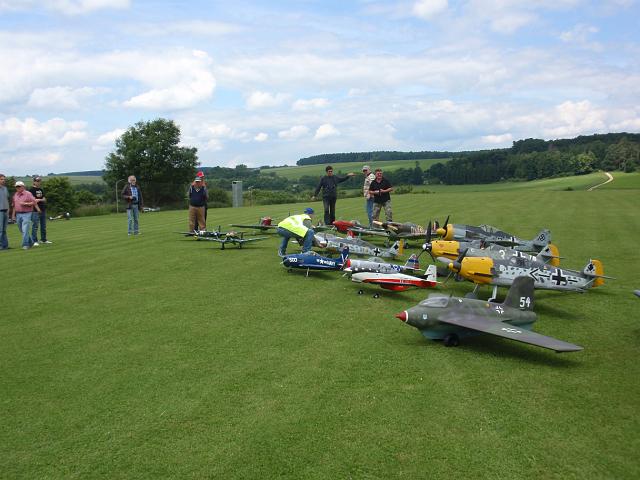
[436,217,551,252]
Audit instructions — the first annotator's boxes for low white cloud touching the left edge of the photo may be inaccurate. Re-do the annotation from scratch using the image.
[0,117,87,151]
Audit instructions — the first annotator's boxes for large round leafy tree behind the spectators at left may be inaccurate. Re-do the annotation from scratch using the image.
[102,118,198,205]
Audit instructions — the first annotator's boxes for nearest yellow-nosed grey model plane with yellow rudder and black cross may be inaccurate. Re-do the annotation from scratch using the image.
[438,248,612,299]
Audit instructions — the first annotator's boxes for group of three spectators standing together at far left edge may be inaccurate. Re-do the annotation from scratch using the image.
[0,173,53,250]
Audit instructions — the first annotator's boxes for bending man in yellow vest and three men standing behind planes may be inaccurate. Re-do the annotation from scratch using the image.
[278,165,393,257]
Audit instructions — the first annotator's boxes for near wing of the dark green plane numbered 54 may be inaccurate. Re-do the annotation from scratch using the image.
[438,314,582,352]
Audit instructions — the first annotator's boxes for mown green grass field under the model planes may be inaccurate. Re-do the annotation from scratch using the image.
[0,177,640,479]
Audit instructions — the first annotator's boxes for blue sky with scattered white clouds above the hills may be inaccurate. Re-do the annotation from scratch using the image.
[0,0,640,175]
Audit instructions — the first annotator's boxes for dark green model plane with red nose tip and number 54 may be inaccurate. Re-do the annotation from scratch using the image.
[396,277,582,352]
